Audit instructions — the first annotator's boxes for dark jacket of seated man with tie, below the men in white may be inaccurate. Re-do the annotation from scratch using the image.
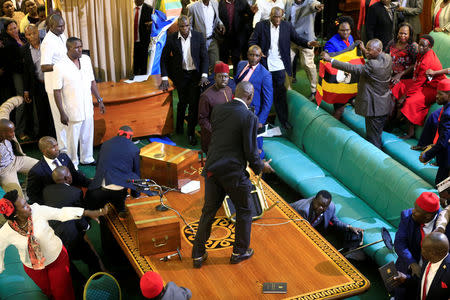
[27,153,91,205]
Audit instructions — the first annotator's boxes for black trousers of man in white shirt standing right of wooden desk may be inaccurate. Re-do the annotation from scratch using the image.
[176,70,200,136]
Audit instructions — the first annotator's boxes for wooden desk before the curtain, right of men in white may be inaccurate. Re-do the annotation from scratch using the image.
[93,75,173,145]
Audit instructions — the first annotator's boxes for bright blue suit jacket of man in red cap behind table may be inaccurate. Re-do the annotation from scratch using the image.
[236,60,273,124]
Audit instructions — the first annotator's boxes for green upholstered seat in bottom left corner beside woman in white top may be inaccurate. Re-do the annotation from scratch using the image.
[0,246,48,300]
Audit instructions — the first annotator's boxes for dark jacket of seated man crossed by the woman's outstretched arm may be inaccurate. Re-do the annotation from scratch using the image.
[42,183,88,255]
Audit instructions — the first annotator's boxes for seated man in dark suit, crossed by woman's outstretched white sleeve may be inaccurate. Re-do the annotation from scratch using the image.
[42,166,104,274]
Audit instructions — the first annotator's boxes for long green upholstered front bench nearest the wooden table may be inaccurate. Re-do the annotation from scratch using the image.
[263,90,432,265]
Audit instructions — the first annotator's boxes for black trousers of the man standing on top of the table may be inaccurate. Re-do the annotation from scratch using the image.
[192,172,252,258]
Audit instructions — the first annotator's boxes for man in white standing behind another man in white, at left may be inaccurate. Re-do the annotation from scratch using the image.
[41,14,67,151]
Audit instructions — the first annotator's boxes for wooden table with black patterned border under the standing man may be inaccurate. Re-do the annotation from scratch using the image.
[107,170,370,300]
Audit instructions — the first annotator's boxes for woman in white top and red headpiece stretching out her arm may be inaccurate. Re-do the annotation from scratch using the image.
[0,190,107,300]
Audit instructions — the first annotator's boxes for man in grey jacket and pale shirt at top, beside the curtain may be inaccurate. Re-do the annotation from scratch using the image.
[187,0,225,73]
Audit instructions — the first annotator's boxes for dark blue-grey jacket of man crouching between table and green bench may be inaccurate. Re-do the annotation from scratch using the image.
[291,197,347,231]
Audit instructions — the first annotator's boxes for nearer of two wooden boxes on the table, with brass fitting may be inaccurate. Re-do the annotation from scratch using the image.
[125,196,181,256]
